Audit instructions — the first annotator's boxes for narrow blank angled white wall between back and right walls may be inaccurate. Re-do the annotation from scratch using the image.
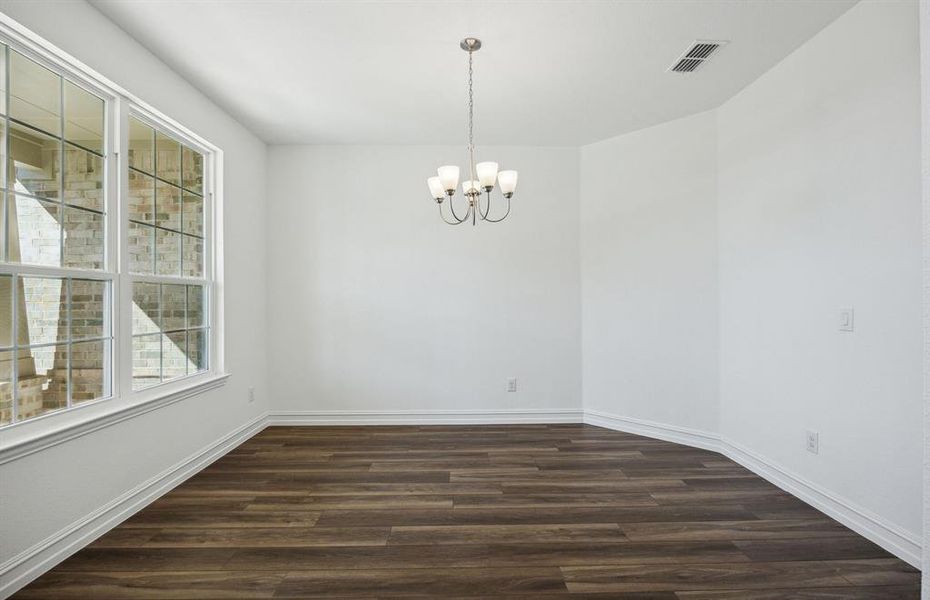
[581,112,718,431]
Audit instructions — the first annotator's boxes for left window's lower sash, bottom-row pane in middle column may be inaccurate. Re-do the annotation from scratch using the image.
[16,344,68,420]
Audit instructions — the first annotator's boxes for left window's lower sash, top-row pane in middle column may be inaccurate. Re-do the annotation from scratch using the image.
[17,277,68,346]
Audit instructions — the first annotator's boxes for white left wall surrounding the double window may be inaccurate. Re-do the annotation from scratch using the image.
[0,0,268,584]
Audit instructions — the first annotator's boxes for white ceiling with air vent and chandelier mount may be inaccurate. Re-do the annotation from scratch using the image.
[91,0,854,145]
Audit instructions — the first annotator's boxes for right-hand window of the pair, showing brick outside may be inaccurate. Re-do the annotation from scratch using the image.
[127,116,209,389]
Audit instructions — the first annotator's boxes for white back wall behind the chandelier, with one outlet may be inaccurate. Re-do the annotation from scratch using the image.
[268,146,581,412]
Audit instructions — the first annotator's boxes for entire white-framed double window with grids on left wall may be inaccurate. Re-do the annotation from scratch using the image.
[0,29,218,427]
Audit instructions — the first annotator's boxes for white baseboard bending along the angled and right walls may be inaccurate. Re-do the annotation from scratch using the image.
[584,410,921,569]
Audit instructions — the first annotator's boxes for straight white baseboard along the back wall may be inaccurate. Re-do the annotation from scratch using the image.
[268,408,584,425]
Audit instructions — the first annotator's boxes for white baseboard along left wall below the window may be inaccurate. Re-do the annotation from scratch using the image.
[0,415,267,598]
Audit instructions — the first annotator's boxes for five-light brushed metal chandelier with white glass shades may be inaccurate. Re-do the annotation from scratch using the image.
[426,38,517,225]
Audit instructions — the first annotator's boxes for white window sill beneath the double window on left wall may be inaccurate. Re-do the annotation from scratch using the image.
[0,373,229,465]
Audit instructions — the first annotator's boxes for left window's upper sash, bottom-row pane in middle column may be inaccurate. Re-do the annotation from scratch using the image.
[7,196,61,267]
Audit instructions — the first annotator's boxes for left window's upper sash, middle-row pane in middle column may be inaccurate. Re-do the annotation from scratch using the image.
[9,123,61,200]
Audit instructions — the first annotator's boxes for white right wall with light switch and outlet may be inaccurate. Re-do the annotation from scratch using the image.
[718,1,922,540]
